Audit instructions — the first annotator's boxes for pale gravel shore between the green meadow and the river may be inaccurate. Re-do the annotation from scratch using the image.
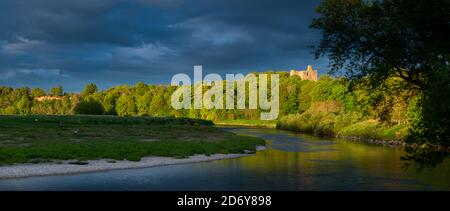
[0,146,266,179]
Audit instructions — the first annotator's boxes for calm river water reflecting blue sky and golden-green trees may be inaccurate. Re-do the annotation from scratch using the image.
[0,127,450,190]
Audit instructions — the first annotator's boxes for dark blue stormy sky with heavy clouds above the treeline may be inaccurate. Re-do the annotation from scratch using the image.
[0,0,327,91]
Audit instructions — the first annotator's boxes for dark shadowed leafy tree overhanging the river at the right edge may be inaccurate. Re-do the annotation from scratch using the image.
[311,0,450,168]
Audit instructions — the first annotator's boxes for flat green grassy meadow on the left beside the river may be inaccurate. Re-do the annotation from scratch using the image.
[0,116,265,165]
